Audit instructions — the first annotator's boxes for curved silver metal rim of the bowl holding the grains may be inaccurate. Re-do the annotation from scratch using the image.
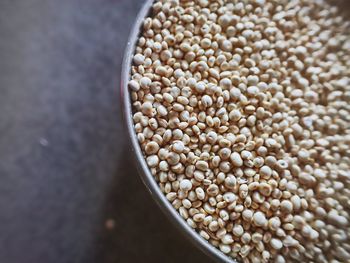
[121,0,236,263]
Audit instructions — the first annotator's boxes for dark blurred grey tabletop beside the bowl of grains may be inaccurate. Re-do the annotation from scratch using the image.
[0,0,211,263]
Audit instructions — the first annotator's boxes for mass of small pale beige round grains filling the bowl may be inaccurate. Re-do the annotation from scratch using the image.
[128,0,350,263]
